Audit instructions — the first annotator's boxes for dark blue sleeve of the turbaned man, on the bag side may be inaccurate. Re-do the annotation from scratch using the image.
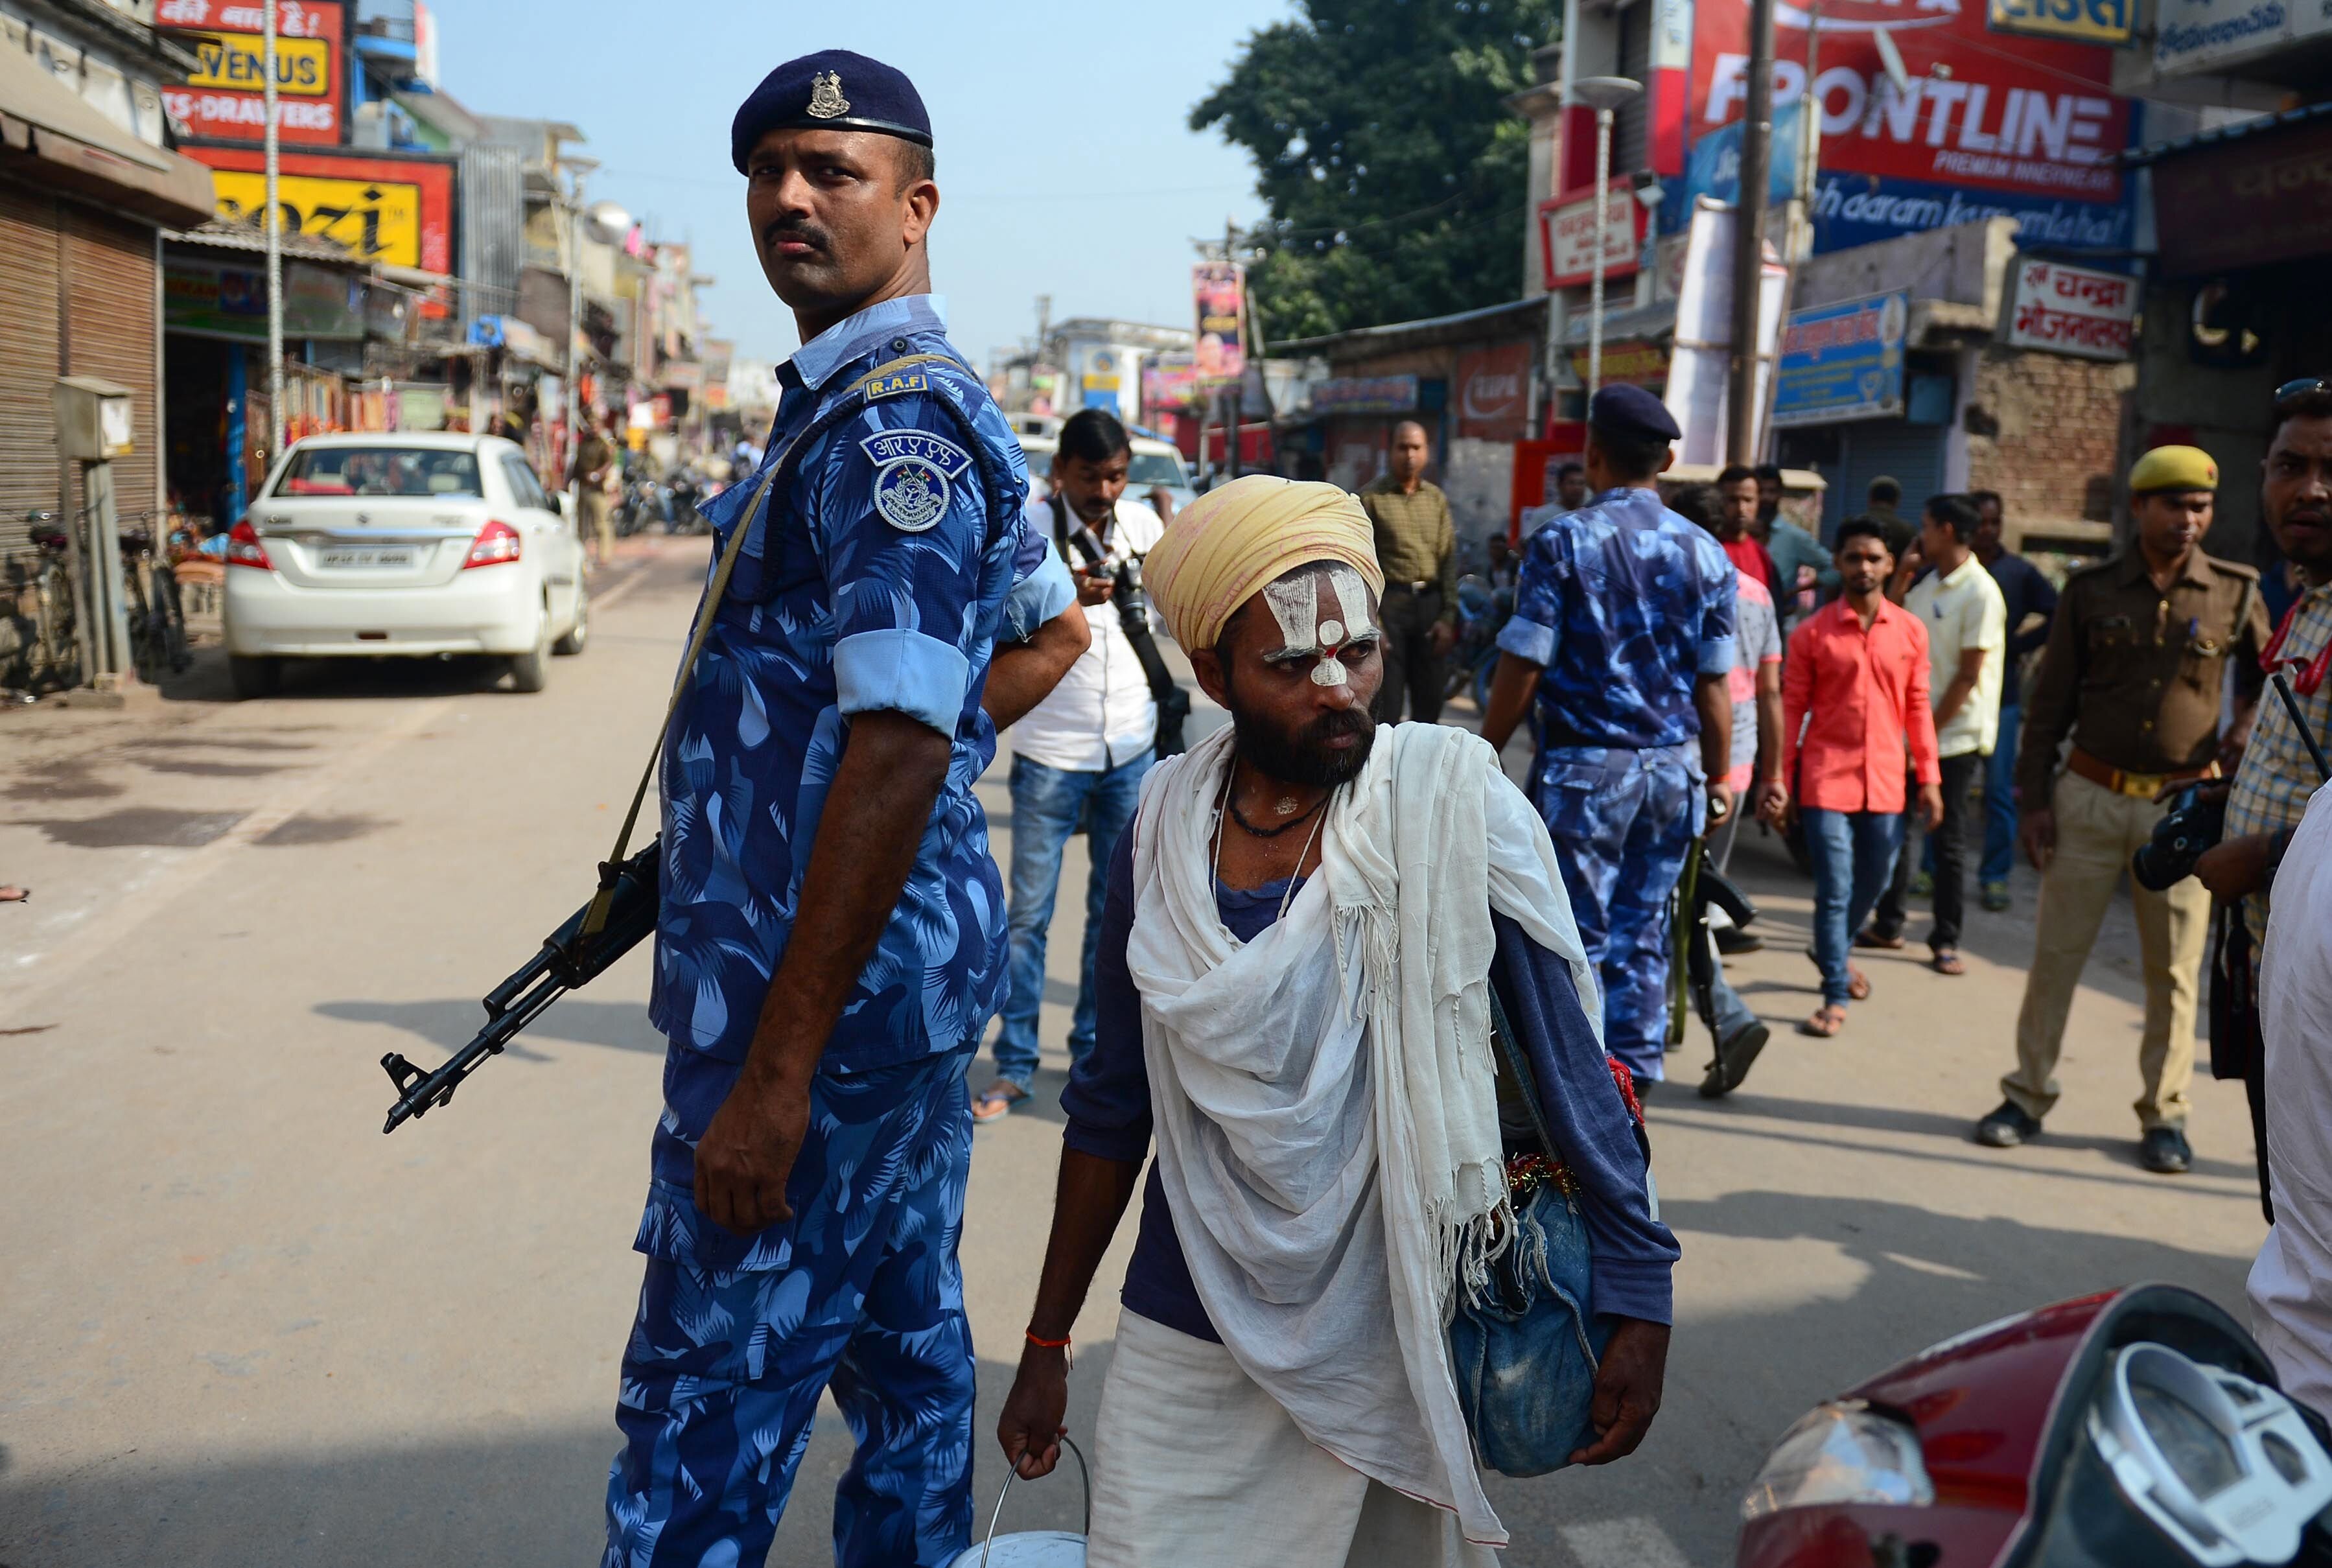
[1493,915,1684,1323]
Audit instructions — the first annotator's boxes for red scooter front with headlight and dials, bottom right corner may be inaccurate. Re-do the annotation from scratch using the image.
[1738,1285,2332,1568]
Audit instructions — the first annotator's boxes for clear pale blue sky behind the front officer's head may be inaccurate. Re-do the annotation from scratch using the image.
[432,0,1292,369]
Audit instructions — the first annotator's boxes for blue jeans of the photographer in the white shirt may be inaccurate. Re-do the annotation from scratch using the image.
[996,751,1154,1090]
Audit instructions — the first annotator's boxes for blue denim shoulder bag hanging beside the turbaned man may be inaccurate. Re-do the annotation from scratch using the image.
[1451,982,1611,1475]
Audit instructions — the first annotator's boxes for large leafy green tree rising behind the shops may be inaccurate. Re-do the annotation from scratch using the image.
[1189,0,1563,341]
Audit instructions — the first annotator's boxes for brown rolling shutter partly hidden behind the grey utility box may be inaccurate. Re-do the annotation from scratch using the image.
[65,205,161,532]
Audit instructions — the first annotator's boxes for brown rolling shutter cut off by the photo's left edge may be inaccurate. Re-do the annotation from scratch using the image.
[0,184,61,551]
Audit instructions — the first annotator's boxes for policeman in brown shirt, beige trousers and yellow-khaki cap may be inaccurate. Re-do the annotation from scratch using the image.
[1976,446,2267,1176]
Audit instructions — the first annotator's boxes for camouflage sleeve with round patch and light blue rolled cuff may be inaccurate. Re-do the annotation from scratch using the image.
[810,401,986,738]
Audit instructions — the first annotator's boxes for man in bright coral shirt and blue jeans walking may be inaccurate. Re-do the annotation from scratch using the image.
[1758,518,1942,1038]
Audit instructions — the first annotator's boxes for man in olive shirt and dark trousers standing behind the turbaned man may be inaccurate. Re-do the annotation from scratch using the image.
[1360,420,1458,723]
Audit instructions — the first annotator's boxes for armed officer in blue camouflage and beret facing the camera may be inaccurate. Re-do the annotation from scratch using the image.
[604,51,1084,1568]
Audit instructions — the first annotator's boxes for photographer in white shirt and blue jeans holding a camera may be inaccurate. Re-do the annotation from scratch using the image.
[972,408,1189,1122]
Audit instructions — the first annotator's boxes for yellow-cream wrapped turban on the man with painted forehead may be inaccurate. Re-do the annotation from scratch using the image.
[1143,474,1385,651]
